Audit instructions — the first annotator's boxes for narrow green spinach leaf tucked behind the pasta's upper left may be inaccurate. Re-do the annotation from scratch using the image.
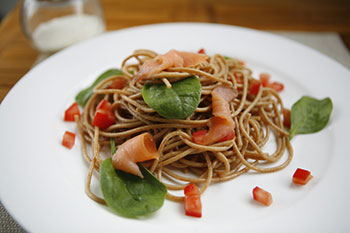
[75,69,123,107]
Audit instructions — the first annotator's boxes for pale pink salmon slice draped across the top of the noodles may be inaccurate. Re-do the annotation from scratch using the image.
[135,49,208,81]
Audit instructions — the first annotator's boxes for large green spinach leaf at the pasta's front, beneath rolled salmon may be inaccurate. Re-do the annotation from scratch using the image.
[100,158,167,218]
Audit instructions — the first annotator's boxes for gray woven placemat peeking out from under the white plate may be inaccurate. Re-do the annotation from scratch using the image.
[0,31,350,233]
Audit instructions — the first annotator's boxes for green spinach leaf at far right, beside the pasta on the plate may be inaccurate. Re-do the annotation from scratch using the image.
[289,96,333,139]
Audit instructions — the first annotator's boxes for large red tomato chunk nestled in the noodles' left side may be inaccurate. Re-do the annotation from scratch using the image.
[92,99,116,129]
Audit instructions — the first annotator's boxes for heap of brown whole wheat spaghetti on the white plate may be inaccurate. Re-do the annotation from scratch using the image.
[76,50,293,203]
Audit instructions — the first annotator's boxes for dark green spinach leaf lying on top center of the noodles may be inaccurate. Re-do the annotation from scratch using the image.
[142,76,202,119]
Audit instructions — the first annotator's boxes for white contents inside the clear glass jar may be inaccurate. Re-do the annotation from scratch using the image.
[32,14,105,53]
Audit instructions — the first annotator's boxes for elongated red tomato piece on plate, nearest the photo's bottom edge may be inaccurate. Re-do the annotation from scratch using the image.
[184,183,202,218]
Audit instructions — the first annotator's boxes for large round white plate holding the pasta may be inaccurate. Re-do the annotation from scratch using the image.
[0,24,350,233]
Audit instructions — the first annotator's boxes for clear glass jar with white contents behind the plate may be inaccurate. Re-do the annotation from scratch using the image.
[21,0,105,54]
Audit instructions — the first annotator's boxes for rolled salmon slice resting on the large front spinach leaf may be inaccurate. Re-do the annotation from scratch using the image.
[112,133,159,178]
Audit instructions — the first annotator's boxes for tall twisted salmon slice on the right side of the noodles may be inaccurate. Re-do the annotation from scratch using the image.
[193,86,238,145]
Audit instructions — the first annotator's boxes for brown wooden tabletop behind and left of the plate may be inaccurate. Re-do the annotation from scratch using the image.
[0,0,350,102]
